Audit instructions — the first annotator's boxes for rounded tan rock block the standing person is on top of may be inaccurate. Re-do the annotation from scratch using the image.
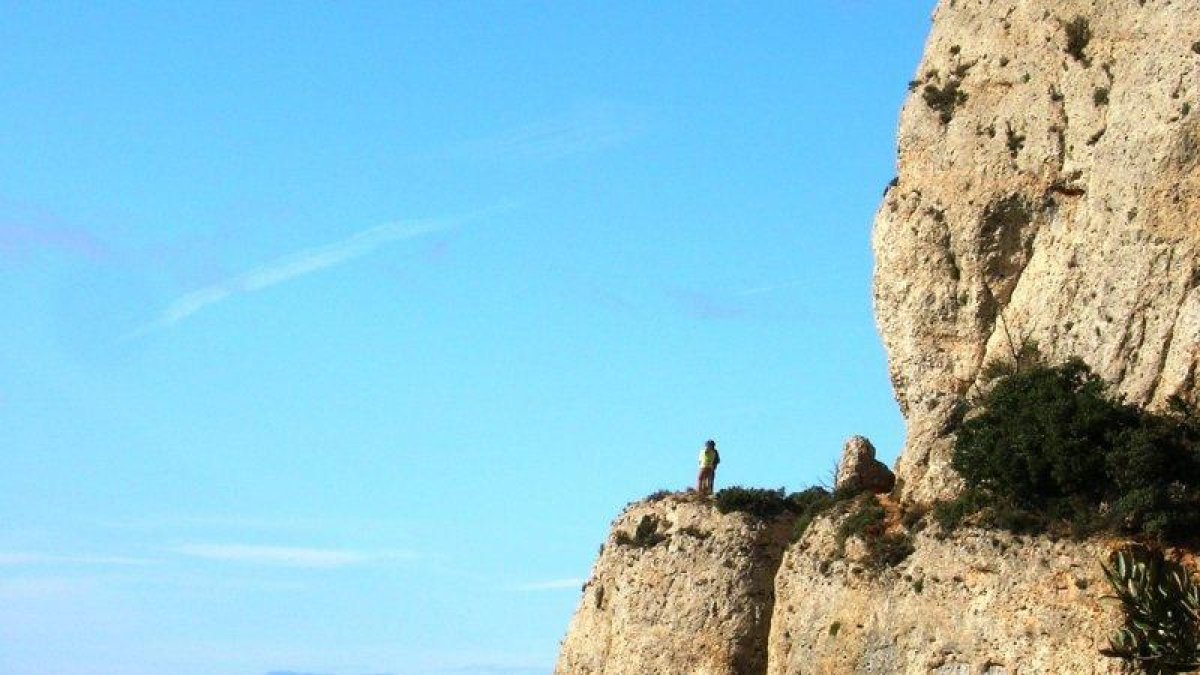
[554,495,792,675]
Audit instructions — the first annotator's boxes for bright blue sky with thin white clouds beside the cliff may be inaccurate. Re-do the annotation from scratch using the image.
[0,0,931,675]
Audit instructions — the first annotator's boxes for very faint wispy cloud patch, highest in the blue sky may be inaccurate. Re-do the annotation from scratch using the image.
[443,104,644,161]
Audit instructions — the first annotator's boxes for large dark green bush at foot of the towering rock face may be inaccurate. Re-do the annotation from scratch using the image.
[935,351,1200,542]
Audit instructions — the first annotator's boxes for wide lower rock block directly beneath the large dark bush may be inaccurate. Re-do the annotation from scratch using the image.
[767,519,1128,675]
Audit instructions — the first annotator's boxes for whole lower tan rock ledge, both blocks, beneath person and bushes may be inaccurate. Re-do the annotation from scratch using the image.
[554,494,1127,675]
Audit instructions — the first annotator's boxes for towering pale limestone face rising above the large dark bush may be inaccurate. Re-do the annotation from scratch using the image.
[872,0,1200,501]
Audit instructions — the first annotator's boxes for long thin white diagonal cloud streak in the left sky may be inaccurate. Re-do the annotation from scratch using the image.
[128,211,475,338]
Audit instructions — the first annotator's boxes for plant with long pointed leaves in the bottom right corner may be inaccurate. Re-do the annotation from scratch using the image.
[1100,549,1200,675]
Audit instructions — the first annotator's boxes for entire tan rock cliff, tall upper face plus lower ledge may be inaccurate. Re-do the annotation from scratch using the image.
[556,0,1200,675]
